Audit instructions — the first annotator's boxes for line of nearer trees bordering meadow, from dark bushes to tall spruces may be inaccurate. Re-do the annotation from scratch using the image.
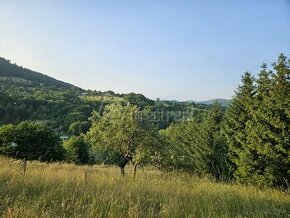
[0,54,290,187]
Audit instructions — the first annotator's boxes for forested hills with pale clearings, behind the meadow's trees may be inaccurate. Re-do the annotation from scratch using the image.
[0,58,209,134]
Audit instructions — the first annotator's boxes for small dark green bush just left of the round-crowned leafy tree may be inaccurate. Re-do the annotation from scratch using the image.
[63,136,92,164]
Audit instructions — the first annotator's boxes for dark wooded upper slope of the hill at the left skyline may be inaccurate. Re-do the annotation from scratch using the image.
[0,57,76,88]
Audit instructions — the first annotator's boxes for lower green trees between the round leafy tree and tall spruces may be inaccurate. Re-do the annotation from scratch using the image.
[162,104,232,180]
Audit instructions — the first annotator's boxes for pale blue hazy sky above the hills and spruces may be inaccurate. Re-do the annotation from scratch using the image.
[0,0,290,100]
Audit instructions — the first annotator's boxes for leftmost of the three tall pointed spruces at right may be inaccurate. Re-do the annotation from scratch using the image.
[222,72,255,182]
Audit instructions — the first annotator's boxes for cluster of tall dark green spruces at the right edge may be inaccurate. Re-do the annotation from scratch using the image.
[224,55,290,187]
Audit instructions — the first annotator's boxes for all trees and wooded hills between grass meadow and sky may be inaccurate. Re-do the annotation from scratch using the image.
[0,54,290,187]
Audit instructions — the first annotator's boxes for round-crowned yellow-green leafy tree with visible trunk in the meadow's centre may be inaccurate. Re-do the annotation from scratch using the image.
[87,104,158,175]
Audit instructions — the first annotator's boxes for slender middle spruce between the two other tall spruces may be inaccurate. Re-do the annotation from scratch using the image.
[245,64,272,185]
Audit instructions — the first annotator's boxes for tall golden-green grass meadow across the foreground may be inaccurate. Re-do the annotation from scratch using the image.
[0,157,290,217]
